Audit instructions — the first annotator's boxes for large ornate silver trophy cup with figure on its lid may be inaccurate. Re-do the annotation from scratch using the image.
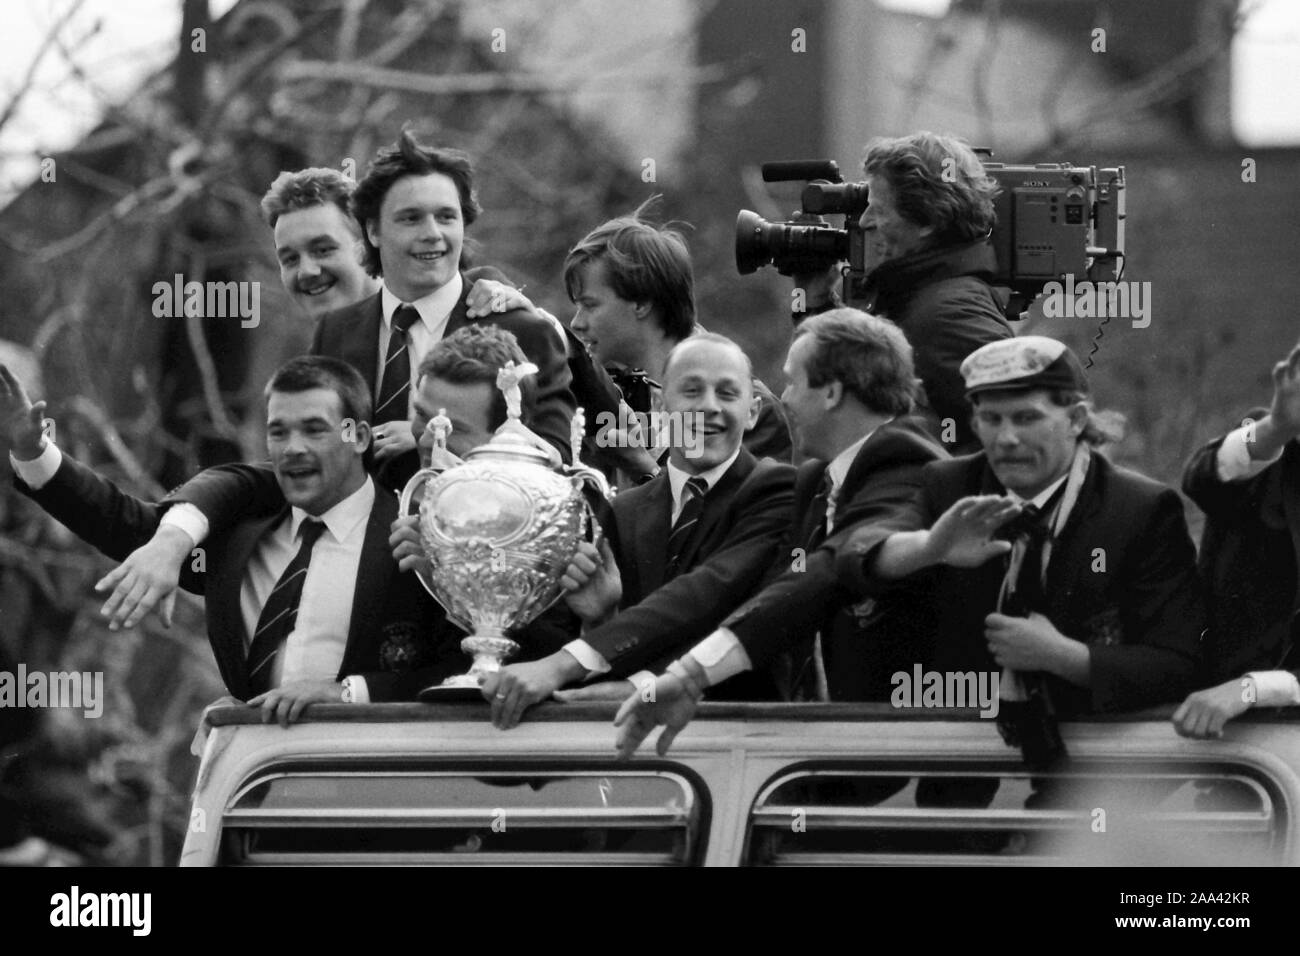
[400,363,611,701]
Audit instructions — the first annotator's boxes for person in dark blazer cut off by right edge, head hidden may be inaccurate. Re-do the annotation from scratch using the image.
[1174,347,1300,737]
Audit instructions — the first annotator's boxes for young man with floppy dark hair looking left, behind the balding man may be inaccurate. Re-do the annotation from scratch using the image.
[564,203,792,468]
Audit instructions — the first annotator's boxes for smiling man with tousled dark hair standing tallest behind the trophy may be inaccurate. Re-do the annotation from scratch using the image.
[325,131,575,489]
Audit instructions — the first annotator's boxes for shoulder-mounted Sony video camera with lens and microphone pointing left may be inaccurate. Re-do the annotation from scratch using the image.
[736,148,1125,320]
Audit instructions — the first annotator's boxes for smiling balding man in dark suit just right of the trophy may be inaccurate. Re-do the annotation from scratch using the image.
[482,333,794,728]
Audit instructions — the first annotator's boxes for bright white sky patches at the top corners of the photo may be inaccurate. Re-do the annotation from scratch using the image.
[0,0,1300,203]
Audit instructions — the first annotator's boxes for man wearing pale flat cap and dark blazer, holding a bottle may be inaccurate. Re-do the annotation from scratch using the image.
[623,336,1204,770]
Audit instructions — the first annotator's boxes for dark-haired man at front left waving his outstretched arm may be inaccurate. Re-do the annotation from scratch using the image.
[0,356,457,724]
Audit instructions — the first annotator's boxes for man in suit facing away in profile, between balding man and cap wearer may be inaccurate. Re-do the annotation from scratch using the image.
[598,308,948,740]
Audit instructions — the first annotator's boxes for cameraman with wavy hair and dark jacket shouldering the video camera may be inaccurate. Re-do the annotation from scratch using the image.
[801,133,1013,454]
